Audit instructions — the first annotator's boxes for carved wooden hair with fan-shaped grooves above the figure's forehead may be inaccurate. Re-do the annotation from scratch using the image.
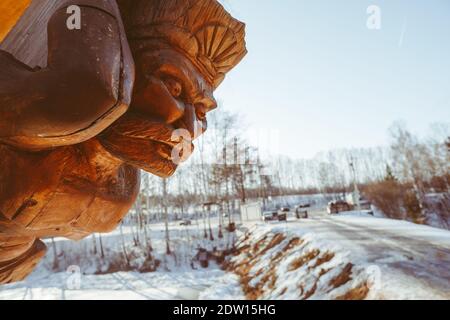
[119,0,247,87]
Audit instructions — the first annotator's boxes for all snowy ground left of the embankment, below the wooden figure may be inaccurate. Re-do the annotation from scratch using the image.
[0,221,244,300]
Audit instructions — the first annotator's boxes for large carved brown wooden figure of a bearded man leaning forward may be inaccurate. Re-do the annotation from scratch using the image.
[0,0,246,283]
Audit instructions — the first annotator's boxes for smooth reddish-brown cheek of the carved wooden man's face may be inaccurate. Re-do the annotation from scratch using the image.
[131,77,185,123]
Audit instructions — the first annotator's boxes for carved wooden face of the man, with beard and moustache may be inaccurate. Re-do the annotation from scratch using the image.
[99,48,217,177]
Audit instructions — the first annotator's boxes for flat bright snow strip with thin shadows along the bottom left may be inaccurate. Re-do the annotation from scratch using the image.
[0,267,243,300]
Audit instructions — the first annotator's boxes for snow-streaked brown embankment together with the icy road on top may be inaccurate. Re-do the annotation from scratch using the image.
[219,214,450,299]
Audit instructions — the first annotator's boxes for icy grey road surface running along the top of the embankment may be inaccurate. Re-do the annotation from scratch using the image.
[287,211,450,299]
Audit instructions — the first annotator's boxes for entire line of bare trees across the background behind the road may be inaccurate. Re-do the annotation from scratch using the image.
[135,112,450,228]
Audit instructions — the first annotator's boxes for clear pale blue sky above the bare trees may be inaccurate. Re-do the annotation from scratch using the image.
[216,0,450,157]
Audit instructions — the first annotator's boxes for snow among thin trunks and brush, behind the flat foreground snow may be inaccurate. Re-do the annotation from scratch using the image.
[37,221,233,274]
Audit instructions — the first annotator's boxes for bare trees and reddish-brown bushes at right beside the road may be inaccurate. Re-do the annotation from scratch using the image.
[365,123,450,228]
